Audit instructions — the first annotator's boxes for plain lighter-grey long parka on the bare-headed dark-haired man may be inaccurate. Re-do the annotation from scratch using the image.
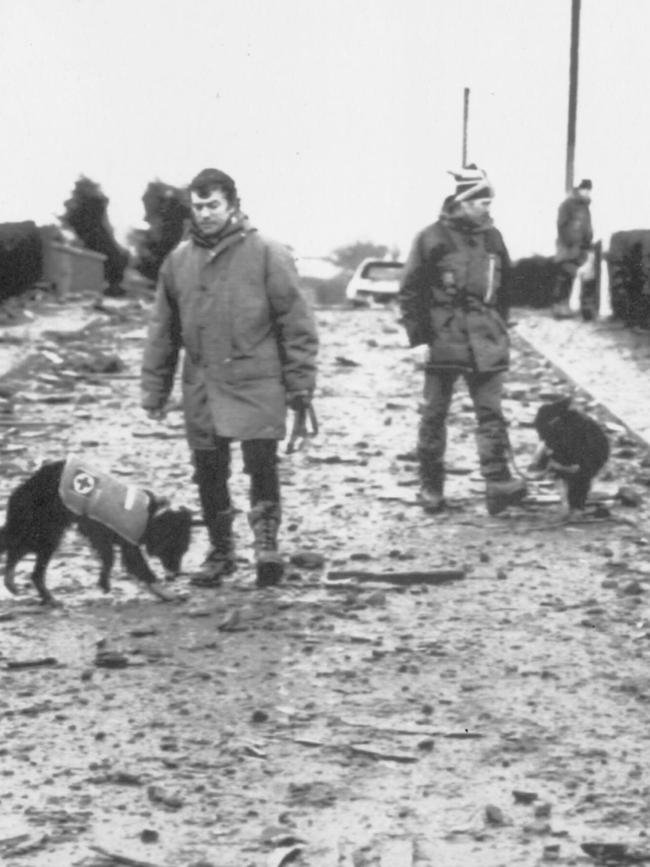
[142,218,318,449]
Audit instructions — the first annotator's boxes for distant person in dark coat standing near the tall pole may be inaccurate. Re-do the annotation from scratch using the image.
[552,179,594,319]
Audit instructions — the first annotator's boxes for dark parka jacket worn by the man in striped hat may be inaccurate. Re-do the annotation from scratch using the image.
[399,215,510,373]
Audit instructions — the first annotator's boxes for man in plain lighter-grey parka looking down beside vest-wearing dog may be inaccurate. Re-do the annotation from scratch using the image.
[142,169,317,587]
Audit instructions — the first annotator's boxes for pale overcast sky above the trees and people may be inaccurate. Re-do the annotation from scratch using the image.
[0,0,650,257]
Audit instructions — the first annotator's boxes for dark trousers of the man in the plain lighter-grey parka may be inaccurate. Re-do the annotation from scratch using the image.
[193,437,280,526]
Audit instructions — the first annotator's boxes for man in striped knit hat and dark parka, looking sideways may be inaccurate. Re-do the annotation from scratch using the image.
[400,165,526,515]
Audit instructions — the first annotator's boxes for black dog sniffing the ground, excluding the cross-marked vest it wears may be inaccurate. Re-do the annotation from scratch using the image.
[0,461,192,604]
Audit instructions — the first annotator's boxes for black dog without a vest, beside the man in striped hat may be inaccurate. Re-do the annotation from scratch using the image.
[534,397,609,511]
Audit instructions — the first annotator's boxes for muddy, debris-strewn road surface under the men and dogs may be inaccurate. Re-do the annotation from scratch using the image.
[0,301,650,867]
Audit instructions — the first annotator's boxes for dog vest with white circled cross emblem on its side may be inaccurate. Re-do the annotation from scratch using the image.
[59,455,150,545]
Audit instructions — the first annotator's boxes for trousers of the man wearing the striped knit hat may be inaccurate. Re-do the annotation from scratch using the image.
[418,370,510,480]
